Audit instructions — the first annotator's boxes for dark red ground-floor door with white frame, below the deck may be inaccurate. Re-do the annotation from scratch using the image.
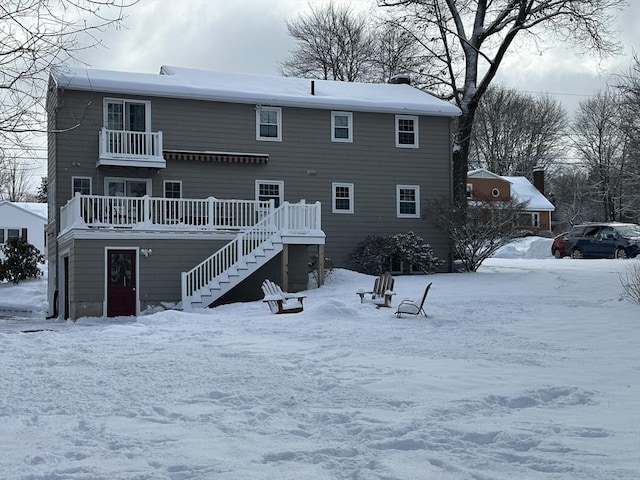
[106,250,137,317]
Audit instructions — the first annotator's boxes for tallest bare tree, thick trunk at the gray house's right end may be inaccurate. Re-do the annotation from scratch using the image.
[378,0,626,205]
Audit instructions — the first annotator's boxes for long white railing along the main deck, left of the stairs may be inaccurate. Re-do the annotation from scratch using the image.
[60,193,274,231]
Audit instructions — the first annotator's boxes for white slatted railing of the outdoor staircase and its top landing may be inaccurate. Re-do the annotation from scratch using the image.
[182,200,321,309]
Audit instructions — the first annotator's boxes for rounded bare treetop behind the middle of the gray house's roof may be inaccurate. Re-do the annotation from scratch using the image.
[281,3,373,82]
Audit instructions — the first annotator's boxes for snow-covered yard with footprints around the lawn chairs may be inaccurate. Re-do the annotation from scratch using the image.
[0,238,640,480]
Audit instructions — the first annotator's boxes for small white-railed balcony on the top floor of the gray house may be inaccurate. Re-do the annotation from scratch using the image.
[98,128,166,168]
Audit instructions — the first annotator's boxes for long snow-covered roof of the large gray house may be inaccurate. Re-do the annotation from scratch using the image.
[52,65,460,117]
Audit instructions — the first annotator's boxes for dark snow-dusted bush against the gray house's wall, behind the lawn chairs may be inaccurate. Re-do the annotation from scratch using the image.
[347,232,444,275]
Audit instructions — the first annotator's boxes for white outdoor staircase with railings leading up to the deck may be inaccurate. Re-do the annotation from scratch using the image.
[182,201,320,311]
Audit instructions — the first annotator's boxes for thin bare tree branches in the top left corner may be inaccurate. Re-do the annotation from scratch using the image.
[0,0,137,195]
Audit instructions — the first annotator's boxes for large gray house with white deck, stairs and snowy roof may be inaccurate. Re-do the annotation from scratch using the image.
[47,66,459,319]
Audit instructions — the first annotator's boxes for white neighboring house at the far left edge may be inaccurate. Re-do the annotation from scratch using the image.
[0,200,47,258]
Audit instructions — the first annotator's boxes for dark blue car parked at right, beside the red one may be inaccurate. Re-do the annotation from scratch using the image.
[566,223,640,258]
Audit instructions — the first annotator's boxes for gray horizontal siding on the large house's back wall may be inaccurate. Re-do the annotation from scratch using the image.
[49,90,452,308]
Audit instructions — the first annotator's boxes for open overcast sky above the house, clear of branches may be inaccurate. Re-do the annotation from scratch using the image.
[75,0,640,112]
